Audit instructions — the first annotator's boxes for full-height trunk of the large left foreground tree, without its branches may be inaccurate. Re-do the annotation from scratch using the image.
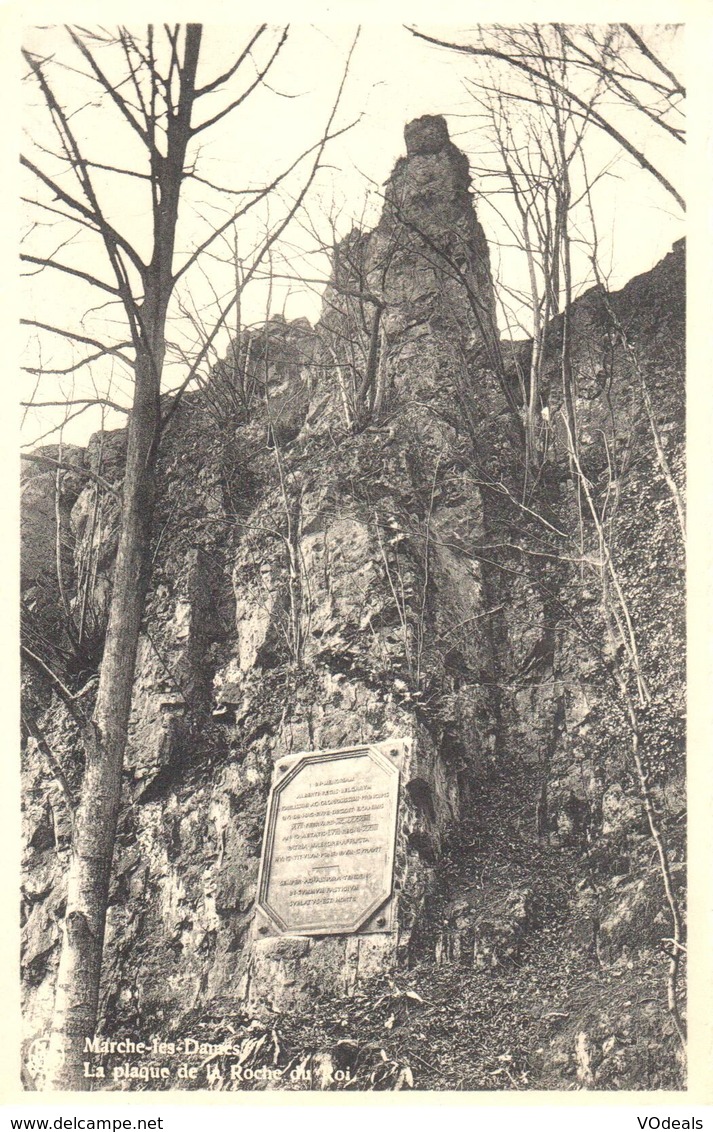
[42,24,201,1090]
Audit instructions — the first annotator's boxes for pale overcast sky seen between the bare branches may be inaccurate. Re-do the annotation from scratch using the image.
[18,22,685,443]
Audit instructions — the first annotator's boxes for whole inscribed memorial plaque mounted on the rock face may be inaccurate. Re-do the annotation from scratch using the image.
[258,745,401,935]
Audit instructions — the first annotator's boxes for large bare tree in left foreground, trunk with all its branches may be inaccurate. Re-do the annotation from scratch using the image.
[23,24,357,1090]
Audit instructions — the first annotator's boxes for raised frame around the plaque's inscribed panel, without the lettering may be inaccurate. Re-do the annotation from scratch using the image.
[256,739,406,936]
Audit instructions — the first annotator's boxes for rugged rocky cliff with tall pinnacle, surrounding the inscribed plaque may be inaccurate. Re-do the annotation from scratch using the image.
[23,118,684,1088]
